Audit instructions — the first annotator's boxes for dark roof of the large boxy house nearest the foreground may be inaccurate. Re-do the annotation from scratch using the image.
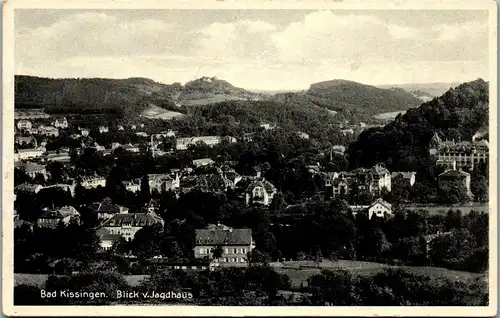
[195,227,252,245]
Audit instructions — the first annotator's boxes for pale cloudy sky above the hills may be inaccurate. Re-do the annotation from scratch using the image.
[15,10,488,90]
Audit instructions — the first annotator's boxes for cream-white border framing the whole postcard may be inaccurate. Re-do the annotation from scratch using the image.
[2,0,498,317]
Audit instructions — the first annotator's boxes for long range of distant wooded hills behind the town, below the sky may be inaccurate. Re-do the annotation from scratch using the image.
[15,76,421,121]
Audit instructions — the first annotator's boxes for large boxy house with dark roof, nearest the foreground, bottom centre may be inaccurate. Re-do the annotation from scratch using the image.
[194,224,255,265]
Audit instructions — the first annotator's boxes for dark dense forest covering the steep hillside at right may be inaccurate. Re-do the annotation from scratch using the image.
[348,79,489,174]
